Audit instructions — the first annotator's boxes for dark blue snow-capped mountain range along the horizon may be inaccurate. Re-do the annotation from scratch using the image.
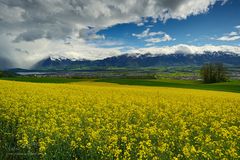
[33,52,240,69]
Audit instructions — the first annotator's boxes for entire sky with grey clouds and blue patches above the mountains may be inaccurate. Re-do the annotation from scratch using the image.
[0,0,240,68]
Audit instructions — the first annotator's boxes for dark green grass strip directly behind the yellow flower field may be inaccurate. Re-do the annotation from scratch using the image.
[1,77,240,93]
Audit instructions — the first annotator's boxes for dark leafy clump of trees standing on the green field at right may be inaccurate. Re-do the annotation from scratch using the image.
[201,63,228,83]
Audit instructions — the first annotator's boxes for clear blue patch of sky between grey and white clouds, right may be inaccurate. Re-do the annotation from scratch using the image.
[97,0,240,47]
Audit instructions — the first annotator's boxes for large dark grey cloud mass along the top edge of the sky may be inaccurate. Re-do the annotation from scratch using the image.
[0,0,225,42]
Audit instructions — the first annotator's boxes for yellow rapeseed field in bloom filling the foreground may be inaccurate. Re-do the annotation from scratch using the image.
[0,80,240,160]
